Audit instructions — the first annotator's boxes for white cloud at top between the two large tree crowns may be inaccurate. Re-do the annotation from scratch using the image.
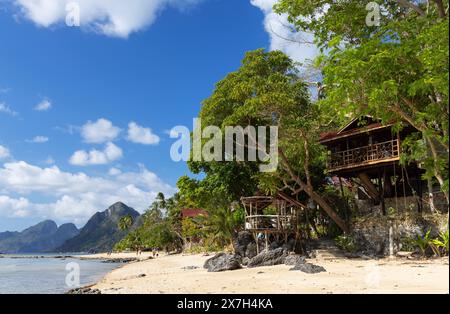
[250,0,319,62]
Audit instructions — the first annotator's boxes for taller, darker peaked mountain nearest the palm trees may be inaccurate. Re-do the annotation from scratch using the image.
[57,202,139,252]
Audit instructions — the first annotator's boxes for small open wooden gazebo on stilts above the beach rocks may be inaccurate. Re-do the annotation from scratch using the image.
[241,192,305,253]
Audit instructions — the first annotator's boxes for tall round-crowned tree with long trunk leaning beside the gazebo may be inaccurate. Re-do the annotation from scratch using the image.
[200,49,348,231]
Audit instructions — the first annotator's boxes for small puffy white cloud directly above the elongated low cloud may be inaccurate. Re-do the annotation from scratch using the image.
[81,118,121,144]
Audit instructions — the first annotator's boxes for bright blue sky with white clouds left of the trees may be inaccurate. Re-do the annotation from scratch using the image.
[0,0,316,231]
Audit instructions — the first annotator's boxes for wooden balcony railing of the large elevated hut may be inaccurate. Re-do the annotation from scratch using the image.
[328,140,400,171]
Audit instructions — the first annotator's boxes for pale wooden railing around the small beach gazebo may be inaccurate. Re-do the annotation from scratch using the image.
[245,215,297,231]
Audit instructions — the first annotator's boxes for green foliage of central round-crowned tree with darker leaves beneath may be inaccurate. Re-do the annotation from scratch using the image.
[191,49,343,233]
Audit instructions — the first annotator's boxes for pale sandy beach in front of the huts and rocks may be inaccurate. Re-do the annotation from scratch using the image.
[81,253,449,294]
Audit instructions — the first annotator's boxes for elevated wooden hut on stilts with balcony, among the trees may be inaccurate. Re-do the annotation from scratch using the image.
[320,116,444,214]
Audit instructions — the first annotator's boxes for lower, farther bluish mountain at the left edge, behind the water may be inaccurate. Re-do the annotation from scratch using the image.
[0,220,79,254]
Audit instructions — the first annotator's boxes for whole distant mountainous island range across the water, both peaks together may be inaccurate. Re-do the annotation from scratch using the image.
[0,202,140,254]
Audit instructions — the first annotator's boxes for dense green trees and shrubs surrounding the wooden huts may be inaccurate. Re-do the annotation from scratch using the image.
[116,0,449,251]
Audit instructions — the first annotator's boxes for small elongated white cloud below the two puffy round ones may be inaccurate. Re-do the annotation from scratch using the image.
[69,142,123,166]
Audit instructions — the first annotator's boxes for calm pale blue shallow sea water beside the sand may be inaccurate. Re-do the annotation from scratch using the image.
[0,255,118,294]
